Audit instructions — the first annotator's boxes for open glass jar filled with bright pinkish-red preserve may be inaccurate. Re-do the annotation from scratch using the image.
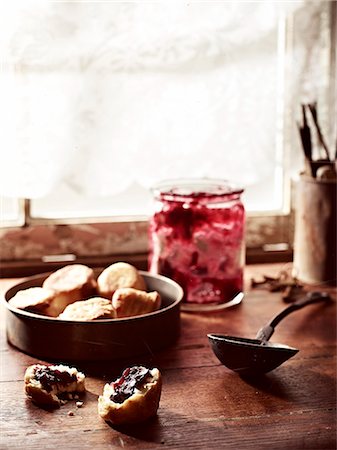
[149,179,245,310]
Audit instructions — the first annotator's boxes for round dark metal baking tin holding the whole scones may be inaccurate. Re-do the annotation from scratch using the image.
[4,271,183,362]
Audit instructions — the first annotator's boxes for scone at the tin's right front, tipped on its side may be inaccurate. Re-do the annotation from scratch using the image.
[112,288,161,317]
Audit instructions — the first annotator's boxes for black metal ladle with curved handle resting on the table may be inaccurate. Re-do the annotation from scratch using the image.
[207,292,330,375]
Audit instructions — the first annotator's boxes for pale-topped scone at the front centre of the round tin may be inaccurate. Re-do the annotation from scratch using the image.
[59,297,116,321]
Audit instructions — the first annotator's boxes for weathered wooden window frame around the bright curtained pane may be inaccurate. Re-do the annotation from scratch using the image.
[0,2,337,277]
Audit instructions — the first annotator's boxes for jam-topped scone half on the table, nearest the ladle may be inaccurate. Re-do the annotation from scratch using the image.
[98,366,162,425]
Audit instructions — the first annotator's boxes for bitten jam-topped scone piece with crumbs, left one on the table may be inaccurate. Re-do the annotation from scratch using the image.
[24,364,85,408]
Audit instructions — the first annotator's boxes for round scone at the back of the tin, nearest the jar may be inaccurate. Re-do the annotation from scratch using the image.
[97,262,146,299]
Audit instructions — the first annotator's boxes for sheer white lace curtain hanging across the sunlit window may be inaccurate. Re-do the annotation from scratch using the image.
[0,0,326,198]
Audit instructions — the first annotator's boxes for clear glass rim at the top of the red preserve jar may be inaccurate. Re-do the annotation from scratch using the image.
[151,178,244,197]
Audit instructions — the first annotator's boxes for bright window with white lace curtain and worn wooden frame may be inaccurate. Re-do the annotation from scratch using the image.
[0,1,336,272]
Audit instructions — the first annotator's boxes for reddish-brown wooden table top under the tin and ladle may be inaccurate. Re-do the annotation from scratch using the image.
[0,264,336,450]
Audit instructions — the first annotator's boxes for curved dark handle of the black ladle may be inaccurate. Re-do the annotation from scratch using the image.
[256,292,330,341]
